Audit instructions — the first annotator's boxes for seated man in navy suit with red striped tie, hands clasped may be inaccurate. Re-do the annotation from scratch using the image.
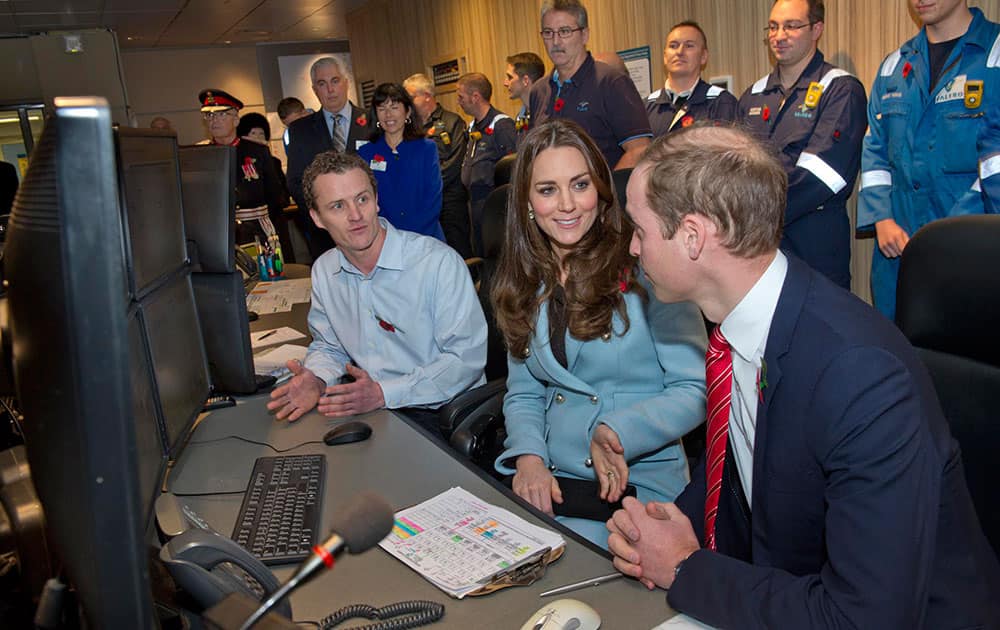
[608,127,1000,628]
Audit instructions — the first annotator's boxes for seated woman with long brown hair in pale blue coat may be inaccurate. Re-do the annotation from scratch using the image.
[492,119,706,547]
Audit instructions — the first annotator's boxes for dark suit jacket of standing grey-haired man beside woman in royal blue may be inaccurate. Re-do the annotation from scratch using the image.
[285,103,375,213]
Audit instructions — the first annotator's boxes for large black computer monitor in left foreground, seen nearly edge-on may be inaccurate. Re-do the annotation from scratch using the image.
[4,98,158,628]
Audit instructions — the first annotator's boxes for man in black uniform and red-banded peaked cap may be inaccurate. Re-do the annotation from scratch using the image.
[198,89,292,260]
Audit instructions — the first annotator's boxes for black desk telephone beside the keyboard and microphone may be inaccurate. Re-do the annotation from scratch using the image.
[157,495,292,619]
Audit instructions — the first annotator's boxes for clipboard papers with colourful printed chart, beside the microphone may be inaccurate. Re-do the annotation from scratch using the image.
[379,488,566,599]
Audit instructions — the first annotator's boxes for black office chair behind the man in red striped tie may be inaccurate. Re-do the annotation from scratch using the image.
[896,215,1000,554]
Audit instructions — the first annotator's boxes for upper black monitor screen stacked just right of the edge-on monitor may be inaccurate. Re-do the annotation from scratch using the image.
[117,128,187,295]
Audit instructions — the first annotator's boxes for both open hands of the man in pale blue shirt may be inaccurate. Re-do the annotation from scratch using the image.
[267,361,385,421]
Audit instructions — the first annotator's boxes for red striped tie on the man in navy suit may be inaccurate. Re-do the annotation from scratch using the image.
[705,326,733,551]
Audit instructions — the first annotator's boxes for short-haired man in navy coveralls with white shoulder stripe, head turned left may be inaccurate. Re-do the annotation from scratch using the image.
[458,72,517,253]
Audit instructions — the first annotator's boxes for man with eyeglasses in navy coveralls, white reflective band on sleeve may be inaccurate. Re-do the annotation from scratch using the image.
[739,0,866,290]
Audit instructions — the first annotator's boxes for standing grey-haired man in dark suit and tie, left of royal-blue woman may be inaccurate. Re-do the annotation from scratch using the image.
[286,57,374,260]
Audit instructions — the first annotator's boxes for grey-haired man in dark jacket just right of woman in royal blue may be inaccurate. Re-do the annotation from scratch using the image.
[403,74,472,258]
